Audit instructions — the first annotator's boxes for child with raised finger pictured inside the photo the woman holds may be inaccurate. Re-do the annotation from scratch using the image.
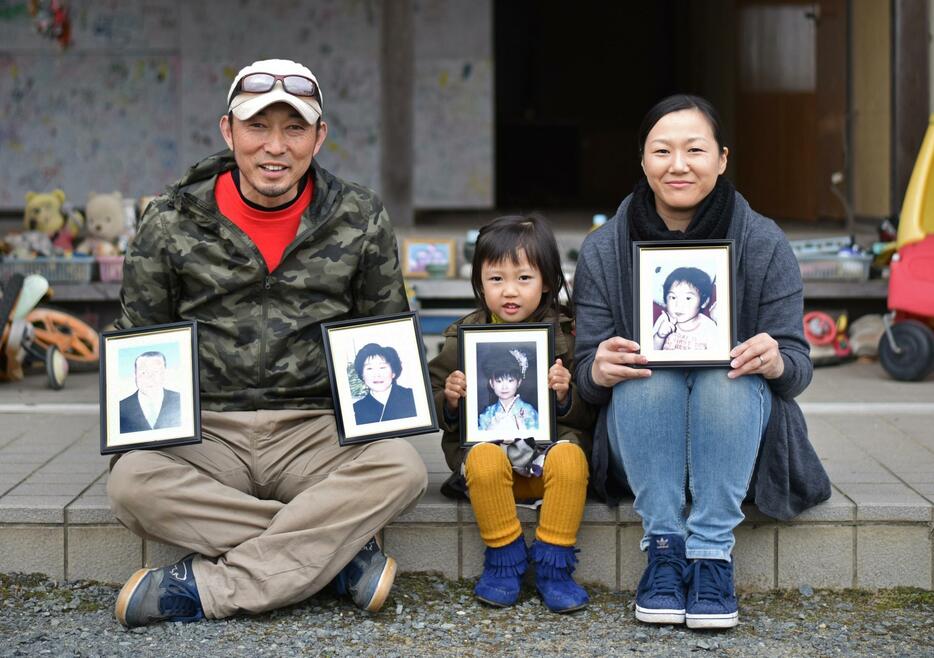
[652,267,718,351]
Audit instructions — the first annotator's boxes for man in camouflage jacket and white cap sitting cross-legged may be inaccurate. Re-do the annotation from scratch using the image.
[107,60,427,626]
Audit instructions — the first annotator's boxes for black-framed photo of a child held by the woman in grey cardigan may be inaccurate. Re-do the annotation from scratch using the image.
[632,240,736,368]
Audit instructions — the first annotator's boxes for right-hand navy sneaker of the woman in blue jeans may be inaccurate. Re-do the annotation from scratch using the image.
[684,560,739,628]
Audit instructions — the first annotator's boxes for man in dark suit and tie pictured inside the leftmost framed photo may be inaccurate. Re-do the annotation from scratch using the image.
[120,350,182,433]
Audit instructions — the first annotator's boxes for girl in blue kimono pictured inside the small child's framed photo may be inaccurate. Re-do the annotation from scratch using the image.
[477,347,538,436]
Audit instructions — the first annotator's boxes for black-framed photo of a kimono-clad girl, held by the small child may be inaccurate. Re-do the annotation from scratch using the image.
[457,323,556,446]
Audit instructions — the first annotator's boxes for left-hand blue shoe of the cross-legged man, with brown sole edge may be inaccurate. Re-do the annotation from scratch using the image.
[114,553,204,628]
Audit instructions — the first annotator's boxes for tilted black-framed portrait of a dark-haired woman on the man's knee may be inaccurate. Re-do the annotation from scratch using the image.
[321,312,438,445]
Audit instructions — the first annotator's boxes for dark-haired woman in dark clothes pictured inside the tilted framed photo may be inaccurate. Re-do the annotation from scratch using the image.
[353,343,415,425]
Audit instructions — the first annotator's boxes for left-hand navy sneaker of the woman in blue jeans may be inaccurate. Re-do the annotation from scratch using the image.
[636,535,687,624]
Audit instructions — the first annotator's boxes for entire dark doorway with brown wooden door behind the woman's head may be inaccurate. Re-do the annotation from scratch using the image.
[494,0,847,219]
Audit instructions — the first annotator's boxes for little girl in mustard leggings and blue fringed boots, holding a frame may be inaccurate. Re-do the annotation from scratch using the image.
[429,216,595,612]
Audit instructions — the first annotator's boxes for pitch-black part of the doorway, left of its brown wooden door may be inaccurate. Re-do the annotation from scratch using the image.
[494,0,704,209]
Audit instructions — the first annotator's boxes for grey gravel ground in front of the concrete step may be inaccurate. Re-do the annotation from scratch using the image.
[0,574,934,658]
